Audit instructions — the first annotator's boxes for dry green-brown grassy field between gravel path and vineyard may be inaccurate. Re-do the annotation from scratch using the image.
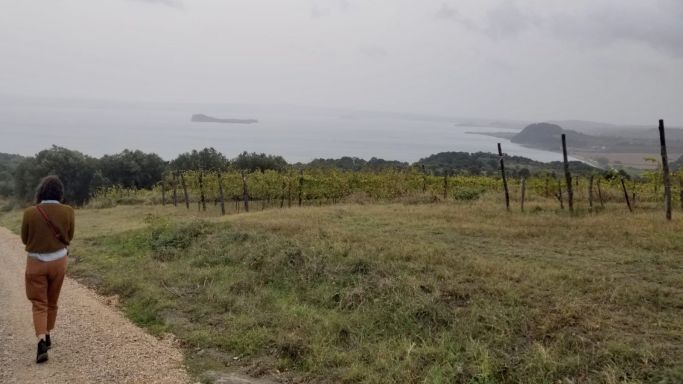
[0,197,683,383]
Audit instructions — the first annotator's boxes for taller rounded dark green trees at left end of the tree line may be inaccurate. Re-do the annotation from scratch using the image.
[0,146,288,205]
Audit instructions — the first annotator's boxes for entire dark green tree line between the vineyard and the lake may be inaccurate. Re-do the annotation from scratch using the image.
[0,146,660,205]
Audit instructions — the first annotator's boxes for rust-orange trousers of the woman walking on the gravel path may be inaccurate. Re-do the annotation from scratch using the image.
[25,256,67,336]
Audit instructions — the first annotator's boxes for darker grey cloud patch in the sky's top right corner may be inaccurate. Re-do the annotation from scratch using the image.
[436,0,683,56]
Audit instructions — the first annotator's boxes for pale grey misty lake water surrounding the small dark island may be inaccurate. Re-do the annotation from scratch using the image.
[0,103,562,162]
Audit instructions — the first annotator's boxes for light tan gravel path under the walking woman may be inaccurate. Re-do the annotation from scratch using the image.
[0,227,190,384]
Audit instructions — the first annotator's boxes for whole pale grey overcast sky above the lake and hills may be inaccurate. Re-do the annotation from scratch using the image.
[0,0,683,125]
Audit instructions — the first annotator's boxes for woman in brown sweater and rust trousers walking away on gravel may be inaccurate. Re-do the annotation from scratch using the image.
[21,176,74,363]
